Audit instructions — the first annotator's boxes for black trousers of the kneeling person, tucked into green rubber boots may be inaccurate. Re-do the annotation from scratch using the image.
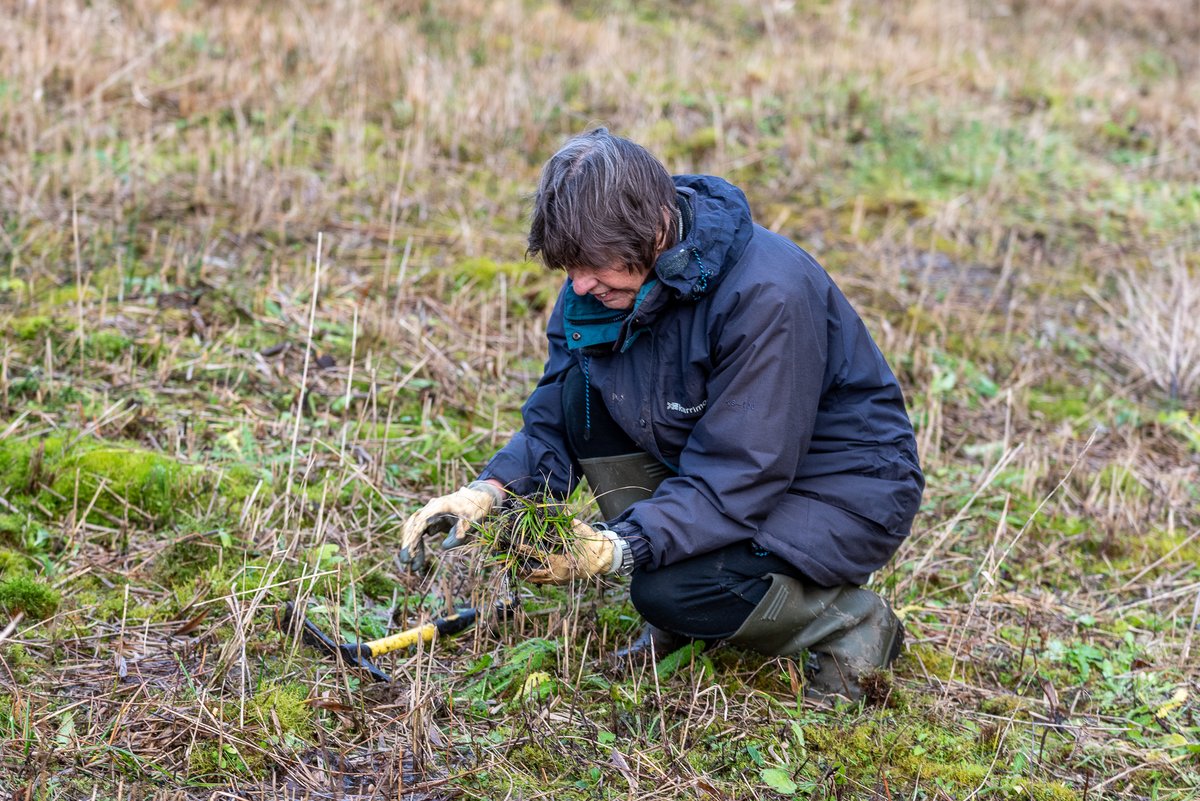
[563,367,804,639]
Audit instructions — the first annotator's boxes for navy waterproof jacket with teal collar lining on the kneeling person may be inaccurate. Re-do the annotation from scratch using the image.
[481,175,924,585]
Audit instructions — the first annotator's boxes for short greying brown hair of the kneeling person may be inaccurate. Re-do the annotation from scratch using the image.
[526,128,676,272]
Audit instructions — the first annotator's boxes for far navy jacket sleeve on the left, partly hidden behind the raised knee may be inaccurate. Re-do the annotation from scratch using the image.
[479,287,580,498]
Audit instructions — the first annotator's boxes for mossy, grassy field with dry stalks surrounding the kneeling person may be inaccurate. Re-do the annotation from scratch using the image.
[0,0,1200,801]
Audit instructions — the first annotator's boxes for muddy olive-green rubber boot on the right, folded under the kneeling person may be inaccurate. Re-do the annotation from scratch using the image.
[728,573,904,700]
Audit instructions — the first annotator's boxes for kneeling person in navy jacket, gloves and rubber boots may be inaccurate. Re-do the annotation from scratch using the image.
[402,128,924,698]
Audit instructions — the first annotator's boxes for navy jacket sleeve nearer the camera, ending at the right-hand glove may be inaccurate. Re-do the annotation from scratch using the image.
[613,268,829,570]
